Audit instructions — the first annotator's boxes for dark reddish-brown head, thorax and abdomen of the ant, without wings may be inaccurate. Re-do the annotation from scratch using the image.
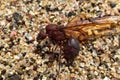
[37,24,80,64]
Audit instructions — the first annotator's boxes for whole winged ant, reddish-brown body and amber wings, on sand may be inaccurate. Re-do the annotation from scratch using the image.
[37,16,120,62]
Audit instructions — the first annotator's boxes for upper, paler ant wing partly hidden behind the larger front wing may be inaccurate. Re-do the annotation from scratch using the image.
[67,14,120,27]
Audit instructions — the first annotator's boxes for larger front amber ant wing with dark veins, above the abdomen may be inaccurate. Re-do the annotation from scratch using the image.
[64,16,120,41]
